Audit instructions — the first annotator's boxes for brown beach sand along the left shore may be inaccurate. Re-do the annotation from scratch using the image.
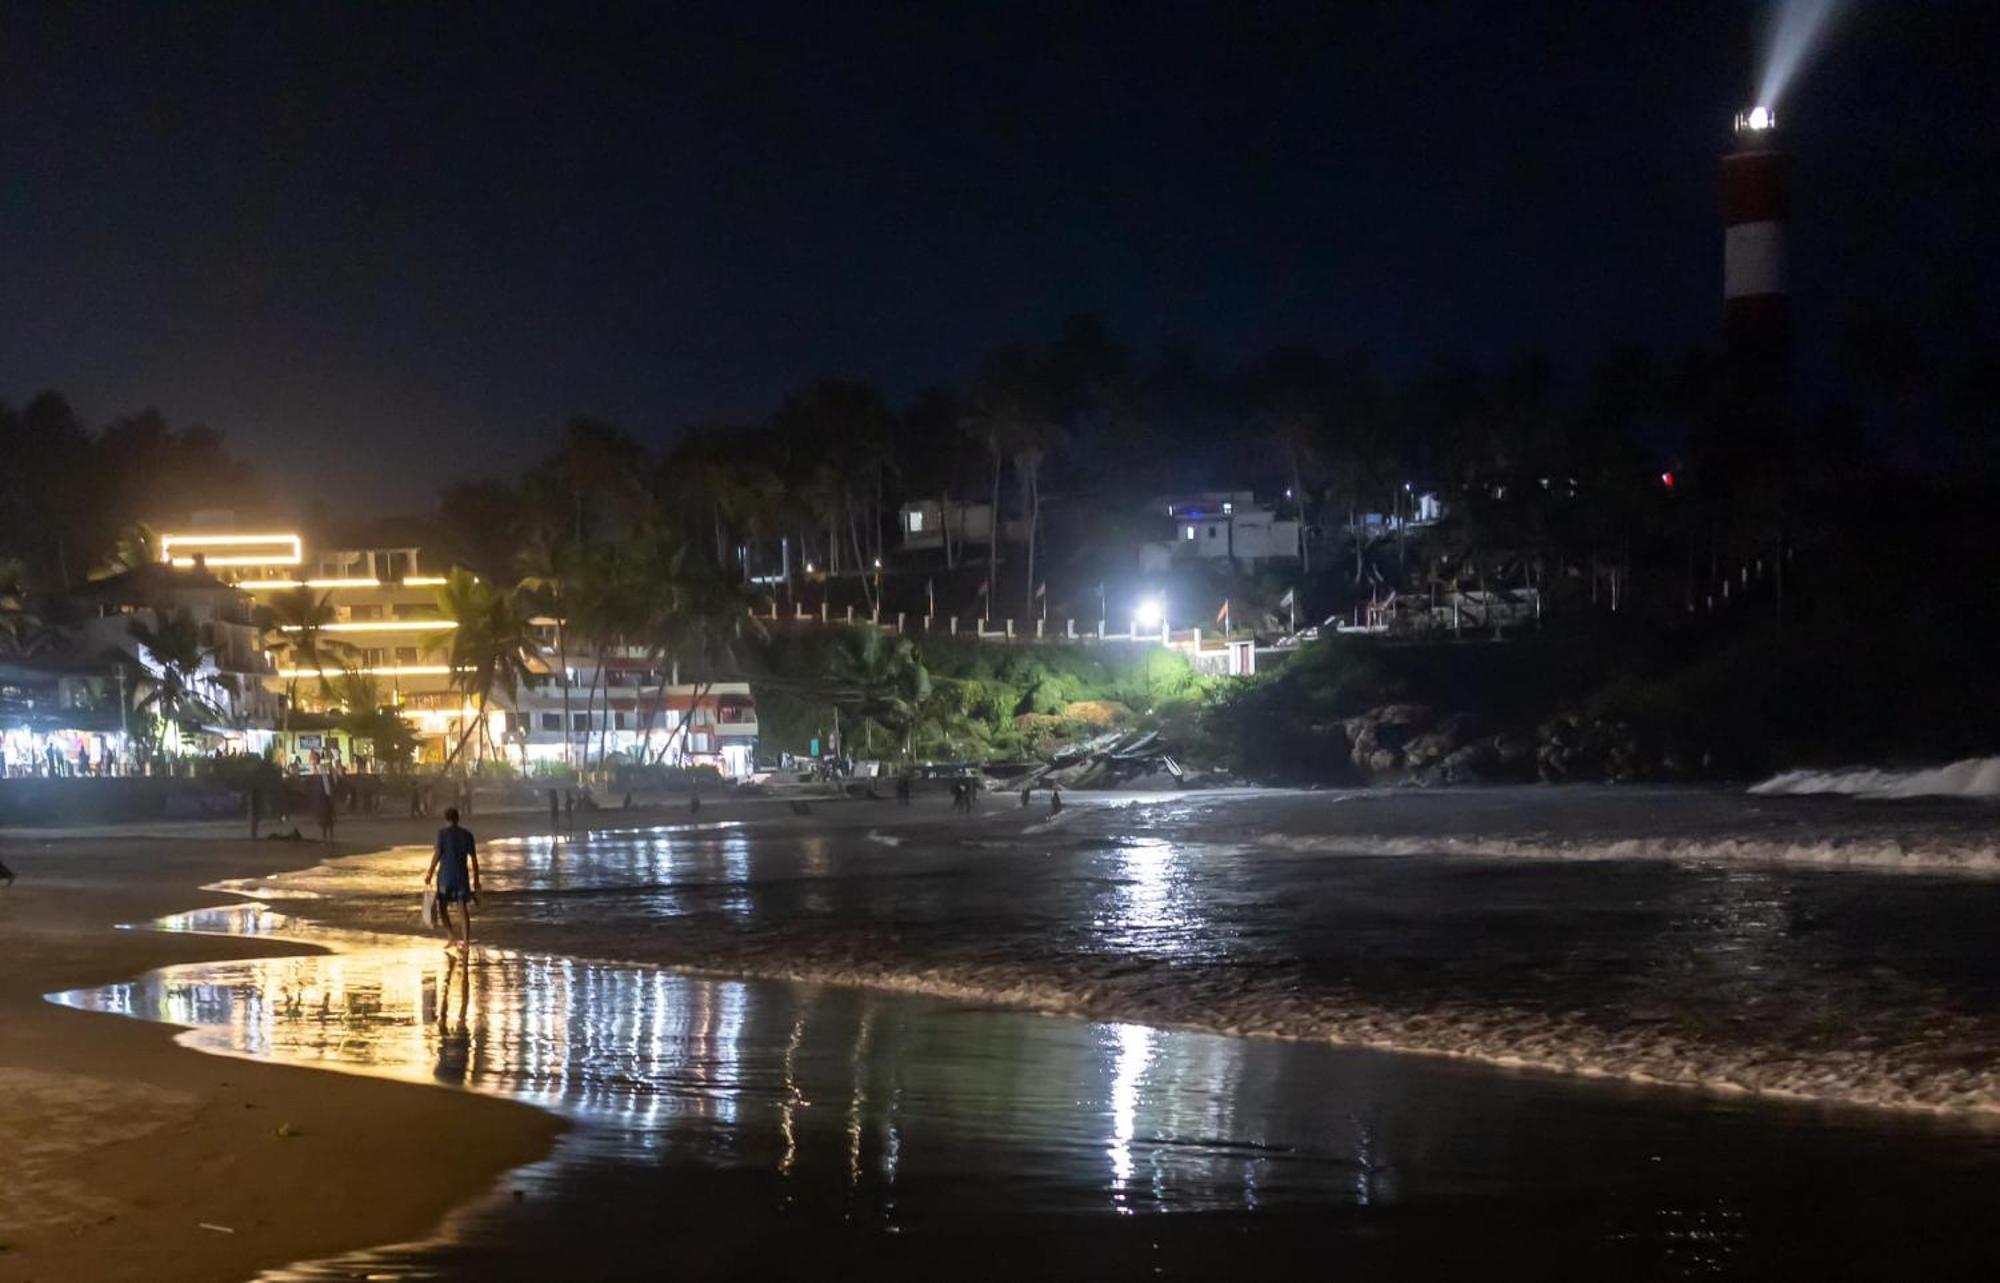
[0,807,724,1283]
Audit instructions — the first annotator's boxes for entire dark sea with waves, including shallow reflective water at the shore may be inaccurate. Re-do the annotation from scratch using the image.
[54,779,2000,1279]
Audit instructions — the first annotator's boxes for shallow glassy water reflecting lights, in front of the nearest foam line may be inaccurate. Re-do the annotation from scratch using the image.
[43,905,2000,1279]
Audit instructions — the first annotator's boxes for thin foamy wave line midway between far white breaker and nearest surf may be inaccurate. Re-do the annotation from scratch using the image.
[1250,833,2000,877]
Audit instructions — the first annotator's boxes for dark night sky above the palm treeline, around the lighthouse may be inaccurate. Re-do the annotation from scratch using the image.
[0,0,2000,510]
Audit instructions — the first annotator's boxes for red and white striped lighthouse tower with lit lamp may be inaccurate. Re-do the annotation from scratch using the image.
[1722,106,1792,376]
